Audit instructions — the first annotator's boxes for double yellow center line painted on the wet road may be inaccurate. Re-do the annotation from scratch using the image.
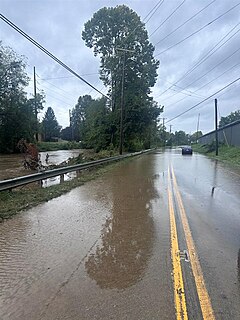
[168,168,215,320]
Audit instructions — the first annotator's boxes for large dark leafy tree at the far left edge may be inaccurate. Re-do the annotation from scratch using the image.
[0,42,43,153]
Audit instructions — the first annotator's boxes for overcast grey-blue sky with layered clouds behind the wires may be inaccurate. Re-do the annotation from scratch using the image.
[0,0,240,133]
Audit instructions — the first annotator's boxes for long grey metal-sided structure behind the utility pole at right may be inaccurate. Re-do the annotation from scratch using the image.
[198,120,240,147]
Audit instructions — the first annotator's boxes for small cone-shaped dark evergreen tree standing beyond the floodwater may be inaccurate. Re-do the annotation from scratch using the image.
[42,107,61,141]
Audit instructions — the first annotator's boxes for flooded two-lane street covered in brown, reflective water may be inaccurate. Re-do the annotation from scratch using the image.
[0,149,240,320]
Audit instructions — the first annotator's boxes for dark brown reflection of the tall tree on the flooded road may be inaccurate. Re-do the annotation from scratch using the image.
[85,158,157,289]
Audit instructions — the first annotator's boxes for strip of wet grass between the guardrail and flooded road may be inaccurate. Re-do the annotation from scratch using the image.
[0,159,122,222]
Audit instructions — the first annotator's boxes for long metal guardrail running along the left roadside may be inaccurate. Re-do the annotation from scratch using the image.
[0,149,153,191]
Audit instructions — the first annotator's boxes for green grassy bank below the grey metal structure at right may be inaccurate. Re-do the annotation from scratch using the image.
[192,144,240,167]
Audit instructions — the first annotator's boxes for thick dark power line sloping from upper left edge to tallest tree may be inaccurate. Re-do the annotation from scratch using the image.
[0,14,110,100]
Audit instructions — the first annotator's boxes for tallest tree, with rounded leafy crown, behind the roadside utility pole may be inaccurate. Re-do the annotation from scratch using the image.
[82,5,161,148]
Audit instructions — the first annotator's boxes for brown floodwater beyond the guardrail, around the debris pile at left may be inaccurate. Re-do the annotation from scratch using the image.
[0,149,81,181]
